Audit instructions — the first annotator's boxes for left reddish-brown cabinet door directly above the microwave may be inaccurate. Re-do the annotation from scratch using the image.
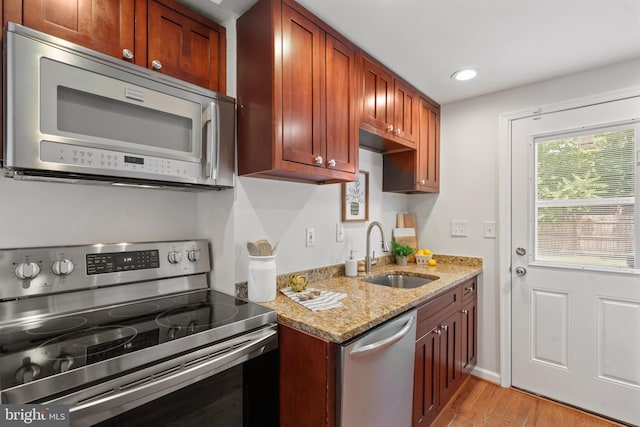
[21,0,134,58]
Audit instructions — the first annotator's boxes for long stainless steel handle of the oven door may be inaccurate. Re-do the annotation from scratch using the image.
[68,328,277,426]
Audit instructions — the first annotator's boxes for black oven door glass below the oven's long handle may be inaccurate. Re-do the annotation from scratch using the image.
[92,351,279,427]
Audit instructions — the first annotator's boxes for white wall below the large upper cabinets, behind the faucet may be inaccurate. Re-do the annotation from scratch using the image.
[234,149,407,281]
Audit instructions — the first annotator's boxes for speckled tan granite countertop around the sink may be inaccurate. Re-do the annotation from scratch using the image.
[261,255,482,344]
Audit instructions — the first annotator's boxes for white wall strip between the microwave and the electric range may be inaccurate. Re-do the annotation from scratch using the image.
[0,171,199,248]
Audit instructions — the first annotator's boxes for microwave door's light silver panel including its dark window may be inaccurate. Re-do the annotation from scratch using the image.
[40,58,202,161]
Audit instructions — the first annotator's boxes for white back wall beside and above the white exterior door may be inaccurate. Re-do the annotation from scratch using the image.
[409,59,640,380]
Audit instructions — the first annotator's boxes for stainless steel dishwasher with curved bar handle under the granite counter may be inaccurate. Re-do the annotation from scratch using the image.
[336,310,416,427]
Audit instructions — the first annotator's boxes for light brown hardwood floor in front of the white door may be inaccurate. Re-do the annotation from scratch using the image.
[433,376,622,427]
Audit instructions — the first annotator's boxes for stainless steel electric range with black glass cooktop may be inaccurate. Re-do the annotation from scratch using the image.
[0,240,278,427]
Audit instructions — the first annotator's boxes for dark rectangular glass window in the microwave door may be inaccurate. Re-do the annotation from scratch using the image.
[57,86,194,153]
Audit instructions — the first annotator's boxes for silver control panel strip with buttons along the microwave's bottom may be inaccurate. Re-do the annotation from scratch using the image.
[40,141,202,179]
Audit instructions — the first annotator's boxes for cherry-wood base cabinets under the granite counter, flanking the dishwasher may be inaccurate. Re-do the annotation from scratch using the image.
[279,277,477,427]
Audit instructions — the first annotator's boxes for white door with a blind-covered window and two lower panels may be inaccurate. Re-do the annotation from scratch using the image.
[511,97,640,425]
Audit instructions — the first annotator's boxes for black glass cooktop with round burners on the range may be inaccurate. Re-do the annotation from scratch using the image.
[0,290,275,387]
